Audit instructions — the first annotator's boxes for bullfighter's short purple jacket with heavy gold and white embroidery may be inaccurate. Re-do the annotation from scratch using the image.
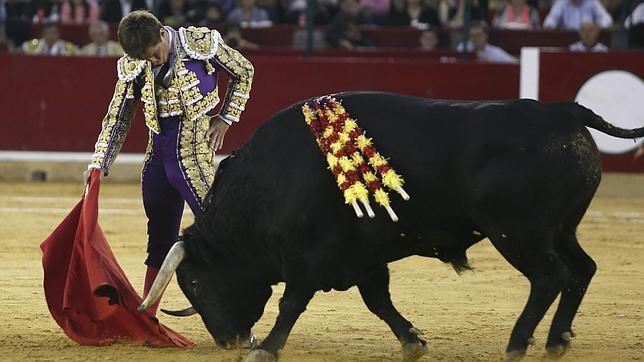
[89,26,254,174]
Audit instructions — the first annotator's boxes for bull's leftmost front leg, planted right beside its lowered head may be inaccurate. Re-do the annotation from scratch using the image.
[244,284,315,362]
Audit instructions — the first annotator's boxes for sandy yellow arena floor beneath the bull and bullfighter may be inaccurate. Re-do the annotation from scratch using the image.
[0,183,644,361]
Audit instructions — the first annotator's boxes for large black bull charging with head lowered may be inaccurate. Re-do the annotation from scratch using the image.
[142,93,644,360]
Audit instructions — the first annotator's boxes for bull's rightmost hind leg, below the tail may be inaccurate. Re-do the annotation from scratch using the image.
[546,230,597,358]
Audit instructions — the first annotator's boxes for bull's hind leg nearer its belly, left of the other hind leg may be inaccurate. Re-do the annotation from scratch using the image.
[491,231,570,360]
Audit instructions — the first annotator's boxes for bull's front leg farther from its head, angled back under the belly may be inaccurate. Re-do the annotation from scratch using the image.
[358,266,427,361]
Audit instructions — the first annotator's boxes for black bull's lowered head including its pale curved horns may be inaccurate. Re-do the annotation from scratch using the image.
[139,241,271,348]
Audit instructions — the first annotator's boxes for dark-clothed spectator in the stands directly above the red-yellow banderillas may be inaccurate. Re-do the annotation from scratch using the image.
[324,0,373,49]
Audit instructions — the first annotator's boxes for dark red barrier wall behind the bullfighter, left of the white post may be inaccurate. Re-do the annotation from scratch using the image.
[0,55,519,152]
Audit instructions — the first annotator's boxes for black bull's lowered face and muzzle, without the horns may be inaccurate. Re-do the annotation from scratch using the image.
[177,259,272,348]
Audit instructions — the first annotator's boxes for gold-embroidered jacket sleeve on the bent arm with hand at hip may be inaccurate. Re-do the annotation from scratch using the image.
[211,36,255,124]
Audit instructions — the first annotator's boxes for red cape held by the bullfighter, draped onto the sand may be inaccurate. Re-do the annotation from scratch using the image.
[40,169,193,347]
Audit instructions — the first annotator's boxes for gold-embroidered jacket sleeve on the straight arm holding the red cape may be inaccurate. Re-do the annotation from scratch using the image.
[88,79,140,175]
